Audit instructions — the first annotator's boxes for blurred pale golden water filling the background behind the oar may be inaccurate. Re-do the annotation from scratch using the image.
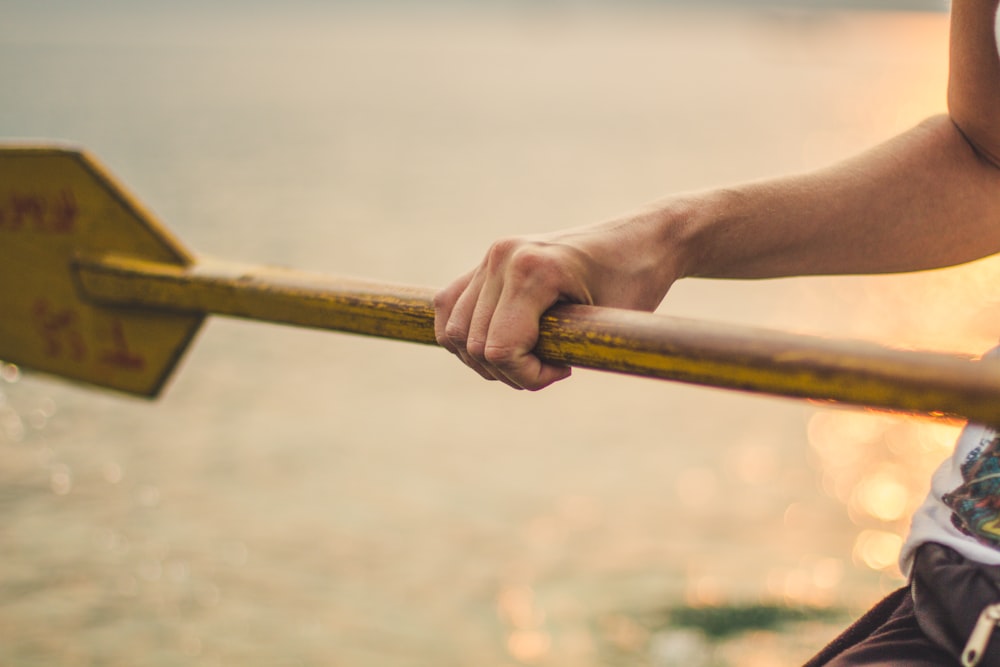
[0,5,1000,666]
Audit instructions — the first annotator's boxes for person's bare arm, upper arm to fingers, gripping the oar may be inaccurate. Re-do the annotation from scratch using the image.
[435,0,1000,390]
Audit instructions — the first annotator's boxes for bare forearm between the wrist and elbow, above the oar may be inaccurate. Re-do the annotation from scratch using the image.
[661,116,1000,278]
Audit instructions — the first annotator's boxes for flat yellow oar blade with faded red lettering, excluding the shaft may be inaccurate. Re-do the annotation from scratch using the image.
[0,146,203,397]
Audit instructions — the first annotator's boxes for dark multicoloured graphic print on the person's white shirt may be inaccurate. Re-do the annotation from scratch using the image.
[941,431,1000,548]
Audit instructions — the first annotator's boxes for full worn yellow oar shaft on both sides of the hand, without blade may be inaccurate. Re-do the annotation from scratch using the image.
[77,257,1000,424]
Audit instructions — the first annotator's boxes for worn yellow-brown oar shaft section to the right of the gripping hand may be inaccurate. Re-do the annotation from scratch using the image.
[537,306,1000,424]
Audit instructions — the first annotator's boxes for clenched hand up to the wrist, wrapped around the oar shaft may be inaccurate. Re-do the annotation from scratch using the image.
[434,214,674,390]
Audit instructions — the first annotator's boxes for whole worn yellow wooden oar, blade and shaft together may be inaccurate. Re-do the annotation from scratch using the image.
[0,146,1000,424]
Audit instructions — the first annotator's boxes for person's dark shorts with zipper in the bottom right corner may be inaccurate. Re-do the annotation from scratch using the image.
[806,544,1000,667]
